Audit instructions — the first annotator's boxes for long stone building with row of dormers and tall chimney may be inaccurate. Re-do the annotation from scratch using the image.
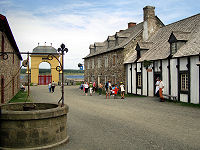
[84,6,163,87]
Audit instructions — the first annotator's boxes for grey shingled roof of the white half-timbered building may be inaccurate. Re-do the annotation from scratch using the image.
[138,14,200,63]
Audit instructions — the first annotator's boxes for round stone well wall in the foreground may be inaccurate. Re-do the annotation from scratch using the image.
[0,103,68,149]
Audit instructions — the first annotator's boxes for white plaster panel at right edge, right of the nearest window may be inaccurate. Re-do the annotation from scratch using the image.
[190,56,199,104]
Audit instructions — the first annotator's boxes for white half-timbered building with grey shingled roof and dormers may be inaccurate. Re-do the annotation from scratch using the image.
[126,14,200,104]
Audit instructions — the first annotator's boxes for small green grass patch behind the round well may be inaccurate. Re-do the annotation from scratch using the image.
[9,91,31,103]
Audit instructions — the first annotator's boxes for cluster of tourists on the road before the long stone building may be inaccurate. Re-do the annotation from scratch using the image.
[80,80,125,99]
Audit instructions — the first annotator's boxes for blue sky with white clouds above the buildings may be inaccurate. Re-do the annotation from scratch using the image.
[0,0,200,69]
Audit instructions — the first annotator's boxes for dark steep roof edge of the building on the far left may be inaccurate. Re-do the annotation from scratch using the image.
[0,14,22,60]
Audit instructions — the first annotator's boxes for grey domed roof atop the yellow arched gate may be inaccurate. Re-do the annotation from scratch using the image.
[32,46,59,55]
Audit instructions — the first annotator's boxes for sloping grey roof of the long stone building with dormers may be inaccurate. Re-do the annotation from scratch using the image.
[84,22,143,59]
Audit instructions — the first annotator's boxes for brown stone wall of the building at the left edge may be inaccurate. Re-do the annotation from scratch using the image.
[0,32,20,103]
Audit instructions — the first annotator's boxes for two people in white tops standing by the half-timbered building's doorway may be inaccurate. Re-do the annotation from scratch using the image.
[155,77,164,102]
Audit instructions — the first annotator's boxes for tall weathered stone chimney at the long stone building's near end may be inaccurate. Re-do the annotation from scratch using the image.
[143,6,160,41]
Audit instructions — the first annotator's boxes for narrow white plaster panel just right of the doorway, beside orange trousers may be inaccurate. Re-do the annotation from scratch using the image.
[162,60,169,94]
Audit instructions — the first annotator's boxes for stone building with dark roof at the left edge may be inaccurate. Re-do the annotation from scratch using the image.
[0,14,22,103]
